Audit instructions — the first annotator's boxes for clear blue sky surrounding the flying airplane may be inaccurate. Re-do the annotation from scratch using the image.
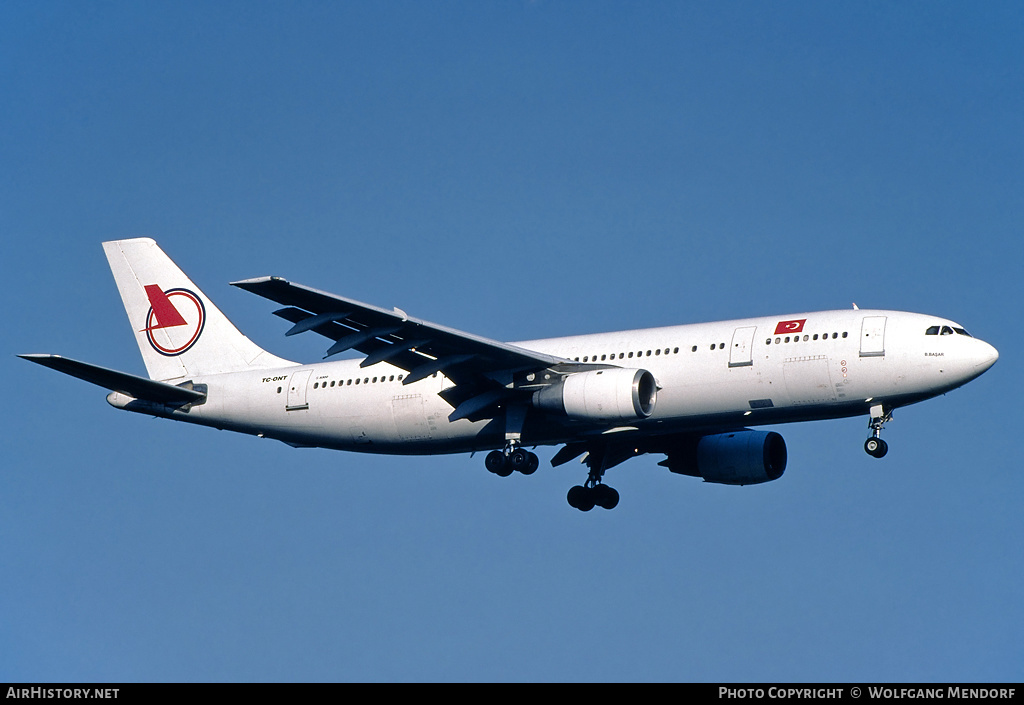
[0,0,1024,681]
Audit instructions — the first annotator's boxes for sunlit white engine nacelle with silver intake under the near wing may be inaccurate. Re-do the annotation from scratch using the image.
[534,368,657,421]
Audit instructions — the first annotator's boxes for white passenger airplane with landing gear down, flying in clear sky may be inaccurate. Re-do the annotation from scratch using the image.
[19,238,998,511]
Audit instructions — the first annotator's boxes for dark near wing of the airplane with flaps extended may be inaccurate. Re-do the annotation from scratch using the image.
[231,277,589,421]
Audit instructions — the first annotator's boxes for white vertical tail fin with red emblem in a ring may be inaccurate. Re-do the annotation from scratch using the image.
[103,238,295,381]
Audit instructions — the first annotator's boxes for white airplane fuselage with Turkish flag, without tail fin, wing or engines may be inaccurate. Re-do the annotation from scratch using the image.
[109,309,997,454]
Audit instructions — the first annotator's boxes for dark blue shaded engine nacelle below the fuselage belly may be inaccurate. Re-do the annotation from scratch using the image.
[697,430,786,485]
